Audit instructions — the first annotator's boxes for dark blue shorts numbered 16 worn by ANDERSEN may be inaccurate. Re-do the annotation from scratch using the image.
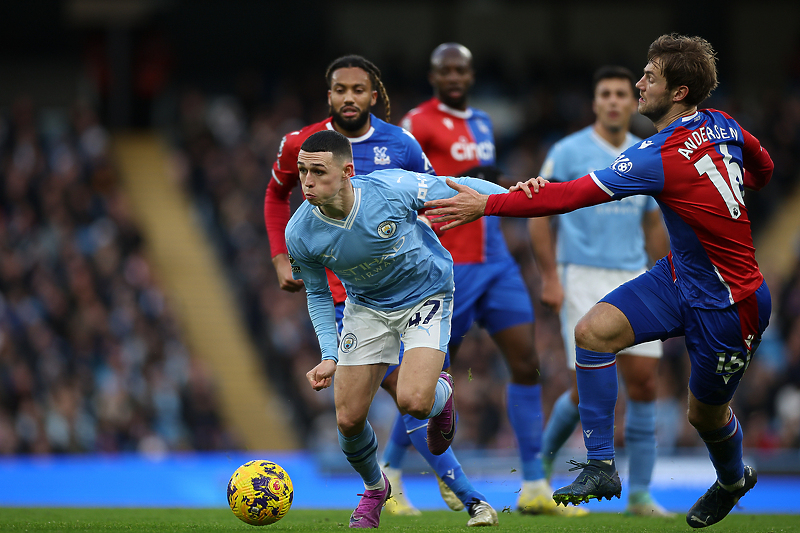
[600,258,772,405]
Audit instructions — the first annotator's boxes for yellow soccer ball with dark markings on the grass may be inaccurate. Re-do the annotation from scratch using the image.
[228,461,294,526]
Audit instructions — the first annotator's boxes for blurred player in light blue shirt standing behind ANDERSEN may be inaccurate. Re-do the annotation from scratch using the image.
[528,66,671,516]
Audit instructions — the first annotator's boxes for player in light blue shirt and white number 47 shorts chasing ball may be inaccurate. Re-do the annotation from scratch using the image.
[286,130,506,528]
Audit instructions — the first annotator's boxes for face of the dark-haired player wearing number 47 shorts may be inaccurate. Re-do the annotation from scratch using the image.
[297,150,353,207]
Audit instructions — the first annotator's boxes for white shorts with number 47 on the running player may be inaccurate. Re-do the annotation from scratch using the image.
[339,293,453,366]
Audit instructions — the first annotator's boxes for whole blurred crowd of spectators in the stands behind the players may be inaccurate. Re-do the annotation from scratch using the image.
[0,57,800,453]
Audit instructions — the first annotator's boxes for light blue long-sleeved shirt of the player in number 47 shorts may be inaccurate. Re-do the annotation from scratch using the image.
[286,169,507,359]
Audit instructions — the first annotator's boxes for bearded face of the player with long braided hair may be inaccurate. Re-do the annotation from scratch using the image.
[328,67,378,136]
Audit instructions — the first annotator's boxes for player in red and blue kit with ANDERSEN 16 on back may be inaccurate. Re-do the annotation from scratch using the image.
[426,34,774,528]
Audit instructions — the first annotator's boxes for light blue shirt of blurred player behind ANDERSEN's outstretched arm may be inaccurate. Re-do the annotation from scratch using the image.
[540,126,658,270]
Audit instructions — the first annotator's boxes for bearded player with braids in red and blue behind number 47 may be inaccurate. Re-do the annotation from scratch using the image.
[264,55,486,515]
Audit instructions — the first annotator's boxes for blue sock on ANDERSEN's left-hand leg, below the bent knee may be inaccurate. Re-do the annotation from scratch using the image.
[575,348,619,460]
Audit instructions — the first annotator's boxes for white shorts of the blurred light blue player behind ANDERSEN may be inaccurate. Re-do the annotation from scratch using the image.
[558,264,663,370]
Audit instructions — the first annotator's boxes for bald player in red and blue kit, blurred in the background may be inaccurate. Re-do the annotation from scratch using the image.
[396,43,586,515]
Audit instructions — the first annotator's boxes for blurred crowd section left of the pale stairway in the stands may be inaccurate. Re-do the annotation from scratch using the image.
[0,98,230,454]
